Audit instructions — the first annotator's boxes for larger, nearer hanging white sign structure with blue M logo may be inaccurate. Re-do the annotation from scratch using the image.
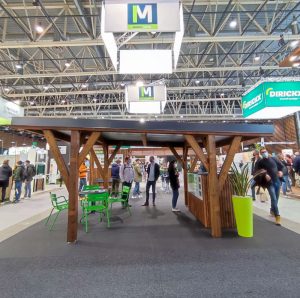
[101,0,184,74]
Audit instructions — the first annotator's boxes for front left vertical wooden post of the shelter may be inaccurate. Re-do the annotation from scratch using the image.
[67,130,80,242]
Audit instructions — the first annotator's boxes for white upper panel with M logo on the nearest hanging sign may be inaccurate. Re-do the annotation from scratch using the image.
[104,0,180,33]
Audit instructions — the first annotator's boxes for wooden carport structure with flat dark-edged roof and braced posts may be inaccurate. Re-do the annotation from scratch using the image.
[12,117,273,242]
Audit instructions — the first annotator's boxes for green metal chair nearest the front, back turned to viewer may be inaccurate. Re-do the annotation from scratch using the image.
[81,192,110,233]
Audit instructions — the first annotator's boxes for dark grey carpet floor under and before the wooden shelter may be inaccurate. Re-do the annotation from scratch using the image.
[0,194,300,298]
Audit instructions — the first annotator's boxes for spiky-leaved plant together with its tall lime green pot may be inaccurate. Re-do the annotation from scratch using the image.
[229,163,253,237]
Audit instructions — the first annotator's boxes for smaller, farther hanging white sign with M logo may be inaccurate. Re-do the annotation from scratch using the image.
[125,85,167,114]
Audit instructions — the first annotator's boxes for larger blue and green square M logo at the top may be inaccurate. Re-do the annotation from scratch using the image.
[127,3,158,30]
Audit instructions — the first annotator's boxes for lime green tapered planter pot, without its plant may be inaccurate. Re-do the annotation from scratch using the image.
[232,196,253,237]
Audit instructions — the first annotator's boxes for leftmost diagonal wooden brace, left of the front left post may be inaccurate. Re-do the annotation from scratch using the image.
[43,130,70,191]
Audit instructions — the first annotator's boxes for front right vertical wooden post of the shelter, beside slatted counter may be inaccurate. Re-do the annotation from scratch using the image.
[207,135,222,237]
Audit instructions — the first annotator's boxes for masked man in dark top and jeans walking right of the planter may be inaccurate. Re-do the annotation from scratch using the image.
[257,147,283,226]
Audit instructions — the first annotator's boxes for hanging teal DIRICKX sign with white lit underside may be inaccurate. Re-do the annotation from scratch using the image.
[242,78,300,119]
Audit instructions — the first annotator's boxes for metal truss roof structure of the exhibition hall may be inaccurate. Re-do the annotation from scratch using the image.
[0,0,300,120]
